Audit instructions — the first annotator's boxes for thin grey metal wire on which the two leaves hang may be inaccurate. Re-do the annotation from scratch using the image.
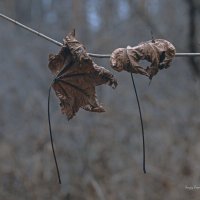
[0,13,200,58]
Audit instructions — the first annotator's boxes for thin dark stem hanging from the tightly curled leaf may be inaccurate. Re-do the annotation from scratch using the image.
[131,72,146,174]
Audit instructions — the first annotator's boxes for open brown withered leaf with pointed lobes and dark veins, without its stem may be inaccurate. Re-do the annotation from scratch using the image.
[49,32,117,120]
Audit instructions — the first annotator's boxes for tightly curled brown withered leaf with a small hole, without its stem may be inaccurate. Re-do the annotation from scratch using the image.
[110,39,176,79]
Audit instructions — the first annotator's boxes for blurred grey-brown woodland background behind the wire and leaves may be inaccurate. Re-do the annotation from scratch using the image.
[0,0,200,200]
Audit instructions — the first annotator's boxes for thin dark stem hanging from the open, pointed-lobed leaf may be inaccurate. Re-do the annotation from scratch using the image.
[48,85,61,184]
